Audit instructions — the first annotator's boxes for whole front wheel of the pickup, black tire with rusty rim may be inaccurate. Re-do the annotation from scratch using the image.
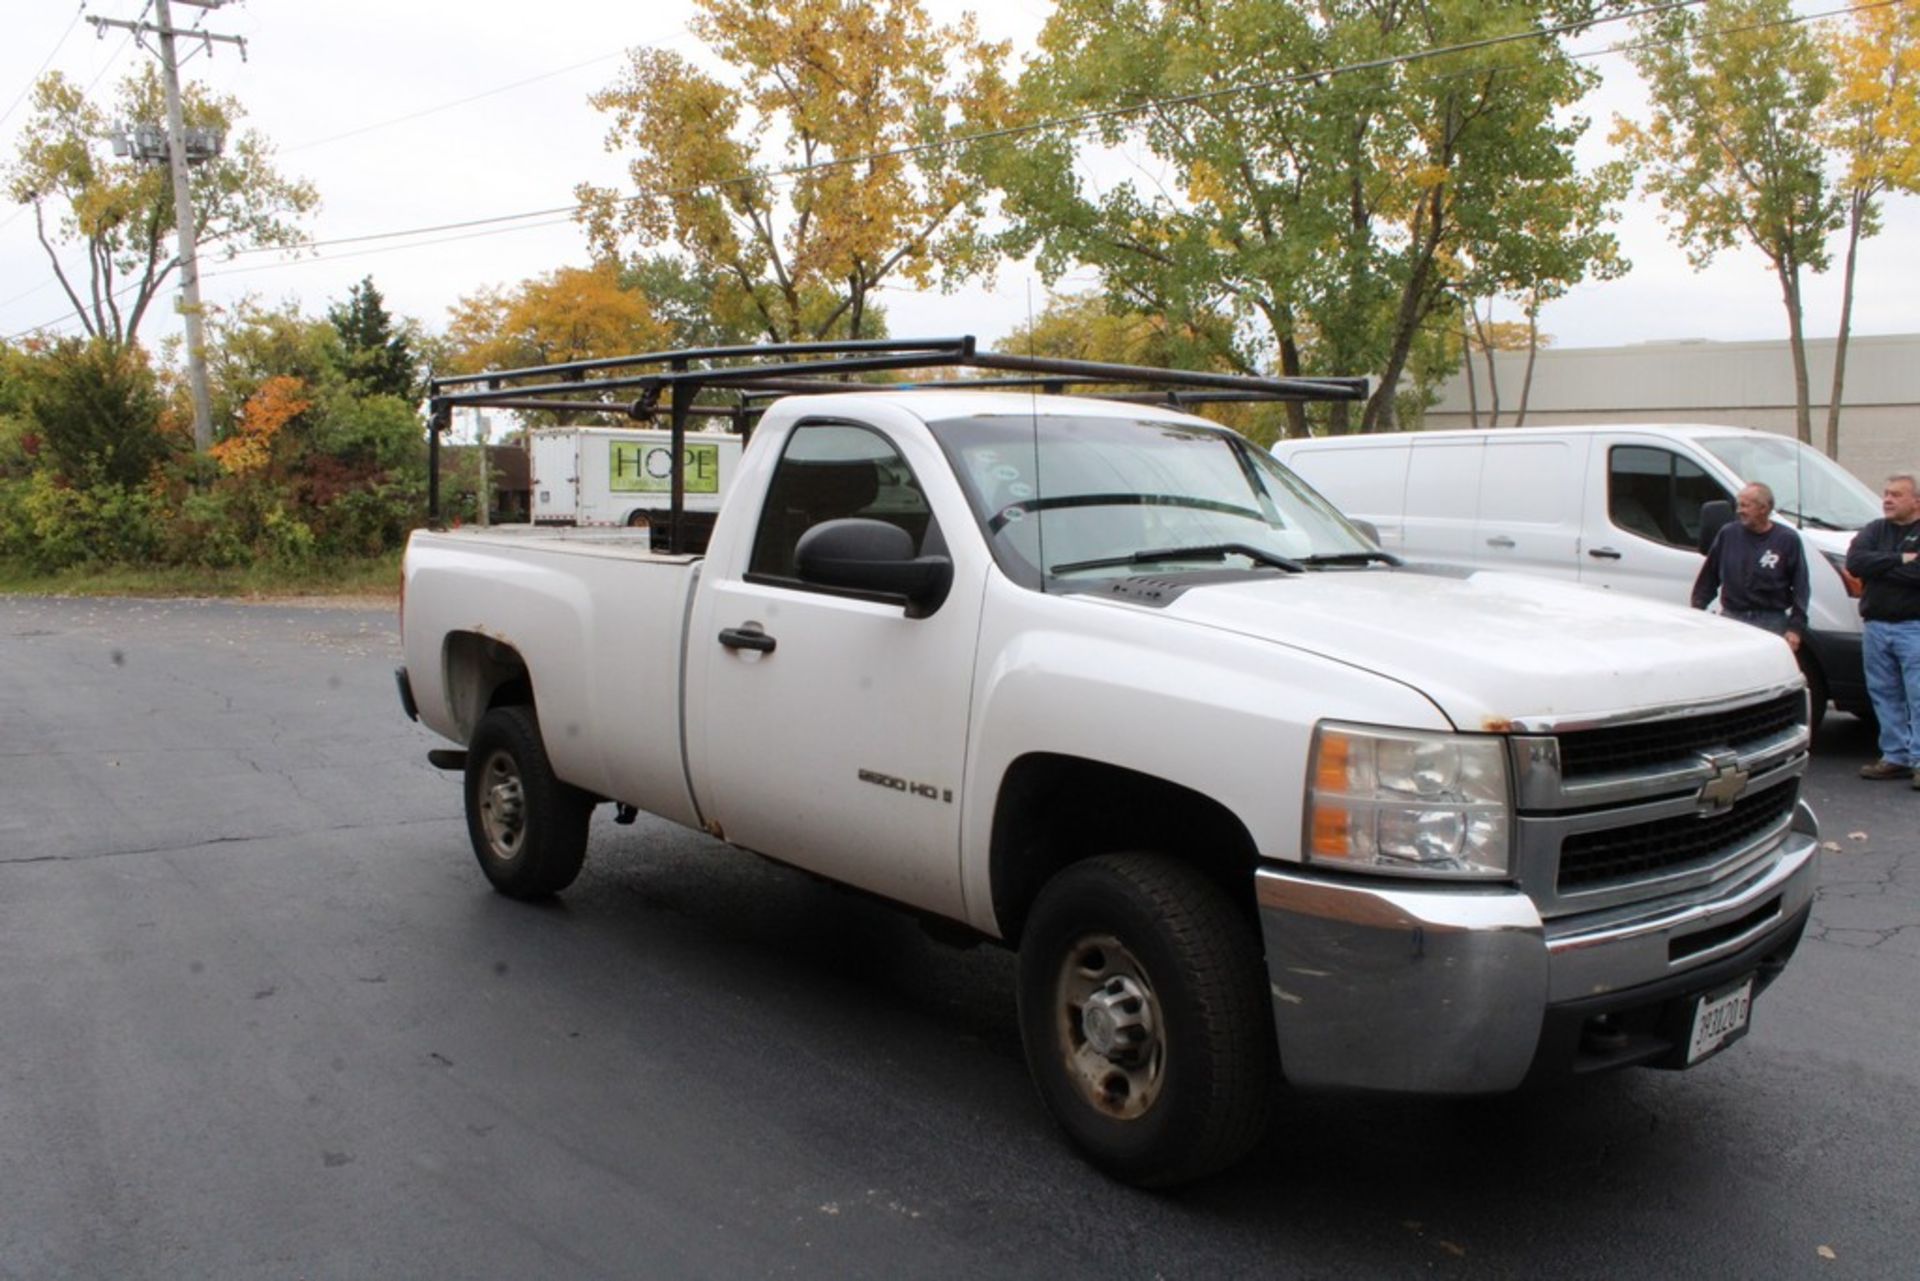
[1020,855,1279,1187]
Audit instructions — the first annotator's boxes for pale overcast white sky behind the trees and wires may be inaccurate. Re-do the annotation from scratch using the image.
[0,0,1920,362]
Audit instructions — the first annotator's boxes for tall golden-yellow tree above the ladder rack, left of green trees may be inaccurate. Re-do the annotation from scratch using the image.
[576,0,1008,342]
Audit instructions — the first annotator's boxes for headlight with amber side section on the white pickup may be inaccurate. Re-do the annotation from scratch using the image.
[1306,724,1513,880]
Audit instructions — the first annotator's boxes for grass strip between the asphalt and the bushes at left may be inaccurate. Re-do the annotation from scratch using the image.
[0,551,399,601]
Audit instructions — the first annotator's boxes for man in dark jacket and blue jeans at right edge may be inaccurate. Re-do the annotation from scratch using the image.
[1847,474,1920,787]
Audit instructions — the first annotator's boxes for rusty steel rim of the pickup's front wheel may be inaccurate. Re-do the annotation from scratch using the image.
[1054,933,1167,1122]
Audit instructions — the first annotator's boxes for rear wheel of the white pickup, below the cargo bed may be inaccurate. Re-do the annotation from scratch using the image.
[467,707,593,899]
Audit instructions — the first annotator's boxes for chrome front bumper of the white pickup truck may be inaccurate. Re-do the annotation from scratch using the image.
[1256,803,1820,1095]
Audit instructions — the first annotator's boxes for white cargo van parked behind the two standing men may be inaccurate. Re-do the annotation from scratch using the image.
[1273,423,1882,729]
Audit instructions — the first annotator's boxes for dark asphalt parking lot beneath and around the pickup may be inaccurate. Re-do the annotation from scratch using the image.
[0,597,1920,1281]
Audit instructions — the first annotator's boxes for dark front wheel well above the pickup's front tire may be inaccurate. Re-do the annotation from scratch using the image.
[991,753,1260,947]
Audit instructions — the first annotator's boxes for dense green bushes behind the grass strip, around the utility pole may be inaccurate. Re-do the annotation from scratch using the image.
[0,307,426,578]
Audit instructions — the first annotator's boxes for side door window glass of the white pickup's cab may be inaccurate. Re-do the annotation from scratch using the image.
[747,423,939,582]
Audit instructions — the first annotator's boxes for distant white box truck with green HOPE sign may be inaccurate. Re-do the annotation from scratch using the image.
[528,426,743,526]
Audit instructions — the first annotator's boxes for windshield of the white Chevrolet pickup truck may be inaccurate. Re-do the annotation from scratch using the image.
[929,415,1392,586]
